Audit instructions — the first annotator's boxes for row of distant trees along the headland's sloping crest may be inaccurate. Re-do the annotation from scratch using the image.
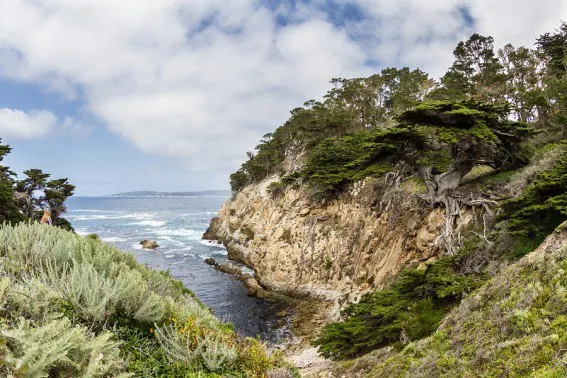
[230,67,434,191]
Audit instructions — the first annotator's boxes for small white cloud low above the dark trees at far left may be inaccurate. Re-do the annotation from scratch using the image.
[0,108,57,139]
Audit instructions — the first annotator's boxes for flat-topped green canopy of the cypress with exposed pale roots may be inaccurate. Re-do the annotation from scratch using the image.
[398,100,531,179]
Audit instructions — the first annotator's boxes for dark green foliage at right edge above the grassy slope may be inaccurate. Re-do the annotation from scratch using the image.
[502,146,567,241]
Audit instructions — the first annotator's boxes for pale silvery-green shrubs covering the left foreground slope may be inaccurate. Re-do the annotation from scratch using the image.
[0,224,291,377]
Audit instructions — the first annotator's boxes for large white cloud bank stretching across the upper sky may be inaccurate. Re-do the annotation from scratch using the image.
[0,0,566,171]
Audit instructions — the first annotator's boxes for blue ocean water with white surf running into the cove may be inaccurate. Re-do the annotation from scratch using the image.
[66,195,285,342]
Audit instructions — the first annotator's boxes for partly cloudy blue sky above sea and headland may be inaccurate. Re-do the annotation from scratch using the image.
[0,0,567,195]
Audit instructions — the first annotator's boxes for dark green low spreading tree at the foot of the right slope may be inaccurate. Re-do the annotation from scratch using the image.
[314,255,484,359]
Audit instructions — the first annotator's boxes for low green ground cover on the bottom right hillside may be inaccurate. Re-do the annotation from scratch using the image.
[362,224,567,377]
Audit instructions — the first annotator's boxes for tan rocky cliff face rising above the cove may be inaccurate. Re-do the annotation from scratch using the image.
[204,179,472,301]
